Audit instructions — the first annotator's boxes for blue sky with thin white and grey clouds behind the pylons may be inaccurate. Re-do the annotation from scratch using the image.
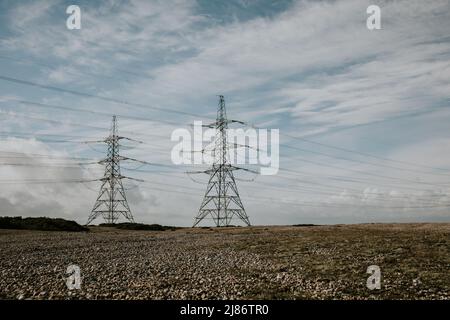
[0,0,450,226]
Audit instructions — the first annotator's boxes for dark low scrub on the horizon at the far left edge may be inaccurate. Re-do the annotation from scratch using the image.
[0,217,89,232]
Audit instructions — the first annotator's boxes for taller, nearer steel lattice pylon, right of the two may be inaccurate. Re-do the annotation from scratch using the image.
[194,96,250,227]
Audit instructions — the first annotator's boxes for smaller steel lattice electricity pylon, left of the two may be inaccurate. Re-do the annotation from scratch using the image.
[86,116,142,225]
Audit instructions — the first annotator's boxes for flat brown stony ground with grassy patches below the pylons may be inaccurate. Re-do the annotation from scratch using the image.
[0,224,450,299]
